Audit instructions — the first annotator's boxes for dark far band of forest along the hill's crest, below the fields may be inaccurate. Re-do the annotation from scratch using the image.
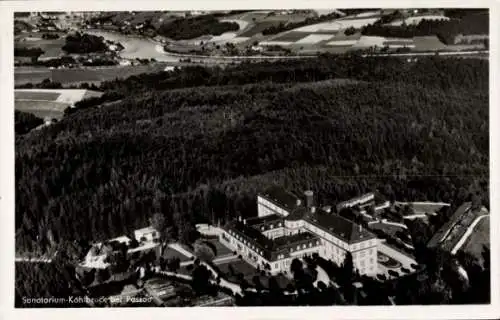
[96,54,488,93]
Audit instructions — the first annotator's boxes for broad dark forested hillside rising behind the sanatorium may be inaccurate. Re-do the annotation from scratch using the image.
[16,58,489,255]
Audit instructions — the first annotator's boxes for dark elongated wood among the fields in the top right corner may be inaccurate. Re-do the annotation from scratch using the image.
[361,13,489,44]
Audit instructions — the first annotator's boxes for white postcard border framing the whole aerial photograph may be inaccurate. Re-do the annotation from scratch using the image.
[0,0,500,320]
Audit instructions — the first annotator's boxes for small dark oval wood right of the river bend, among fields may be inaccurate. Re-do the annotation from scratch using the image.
[157,15,239,40]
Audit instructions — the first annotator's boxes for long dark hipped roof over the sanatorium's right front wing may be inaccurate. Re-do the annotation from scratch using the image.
[306,210,375,243]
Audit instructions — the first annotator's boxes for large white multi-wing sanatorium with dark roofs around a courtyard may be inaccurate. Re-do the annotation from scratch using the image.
[220,187,377,275]
